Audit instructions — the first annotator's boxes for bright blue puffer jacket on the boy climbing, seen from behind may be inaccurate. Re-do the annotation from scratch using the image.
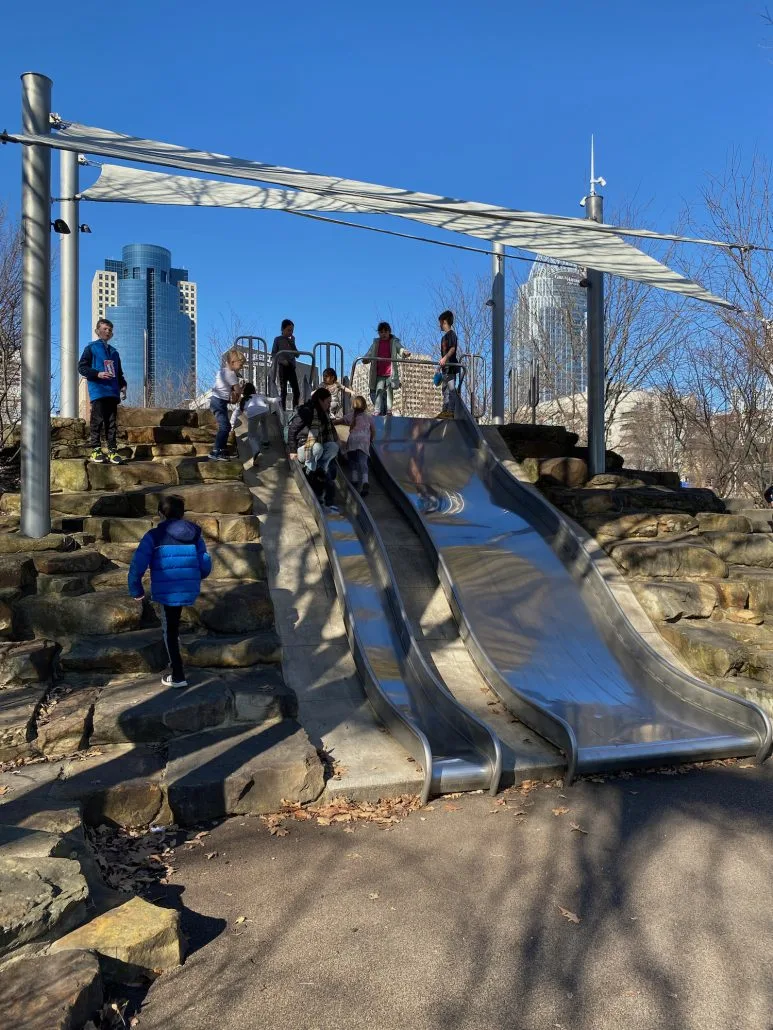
[129,518,212,607]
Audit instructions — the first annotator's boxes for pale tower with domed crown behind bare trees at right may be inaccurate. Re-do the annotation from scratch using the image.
[512,261,587,407]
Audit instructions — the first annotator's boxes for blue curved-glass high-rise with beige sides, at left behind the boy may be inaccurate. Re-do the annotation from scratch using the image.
[92,243,197,407]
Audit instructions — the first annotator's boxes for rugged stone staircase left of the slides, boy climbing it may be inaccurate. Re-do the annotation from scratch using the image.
[0,408,324,836]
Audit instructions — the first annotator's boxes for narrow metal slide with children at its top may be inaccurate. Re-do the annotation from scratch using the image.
[292,461,502,800]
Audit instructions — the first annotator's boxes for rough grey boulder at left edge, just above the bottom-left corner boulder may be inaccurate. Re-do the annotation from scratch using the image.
[0,857,89,955]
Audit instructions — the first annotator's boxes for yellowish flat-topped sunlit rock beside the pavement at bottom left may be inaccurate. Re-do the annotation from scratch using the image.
[52,898,182,983]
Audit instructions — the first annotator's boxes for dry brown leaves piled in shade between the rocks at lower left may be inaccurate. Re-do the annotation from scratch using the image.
[86,825,177,894]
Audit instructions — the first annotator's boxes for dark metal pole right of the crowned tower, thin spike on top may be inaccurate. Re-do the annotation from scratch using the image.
[584,137,606,476]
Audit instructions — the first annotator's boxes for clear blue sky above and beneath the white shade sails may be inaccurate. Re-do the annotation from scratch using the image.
[0,0,773,387]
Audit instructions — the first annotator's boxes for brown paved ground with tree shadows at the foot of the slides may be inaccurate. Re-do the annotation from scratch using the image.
[138,763,773,1030]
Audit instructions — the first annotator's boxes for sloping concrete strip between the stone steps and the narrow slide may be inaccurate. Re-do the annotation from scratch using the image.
[242,426,422,799]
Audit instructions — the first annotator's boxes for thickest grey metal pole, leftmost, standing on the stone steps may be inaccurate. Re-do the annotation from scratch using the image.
[21,72,53,537]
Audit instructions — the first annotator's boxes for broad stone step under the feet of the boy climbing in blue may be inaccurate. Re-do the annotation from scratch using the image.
[90,668,298,747]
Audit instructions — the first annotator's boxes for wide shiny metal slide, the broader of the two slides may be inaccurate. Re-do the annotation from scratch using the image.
[372,407,772,782]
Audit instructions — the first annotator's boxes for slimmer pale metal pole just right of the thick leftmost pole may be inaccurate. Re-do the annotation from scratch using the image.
[59,150,80,418]
